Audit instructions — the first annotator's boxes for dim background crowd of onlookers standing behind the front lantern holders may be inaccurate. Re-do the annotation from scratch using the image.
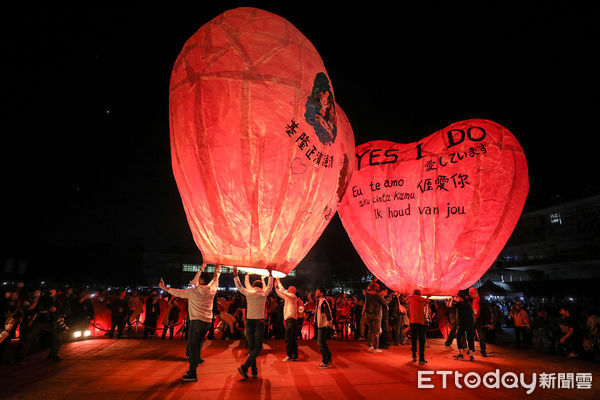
[0,283,600,363]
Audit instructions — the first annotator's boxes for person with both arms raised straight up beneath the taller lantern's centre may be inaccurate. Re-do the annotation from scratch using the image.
[233,267,273,379]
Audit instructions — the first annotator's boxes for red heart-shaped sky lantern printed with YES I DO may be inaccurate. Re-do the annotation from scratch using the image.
[338,119,529,295]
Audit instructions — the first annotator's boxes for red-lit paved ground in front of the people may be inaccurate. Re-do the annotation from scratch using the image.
[0,339,600,400]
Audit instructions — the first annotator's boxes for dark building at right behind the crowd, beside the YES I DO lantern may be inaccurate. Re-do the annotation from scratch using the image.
[479,196,600,296]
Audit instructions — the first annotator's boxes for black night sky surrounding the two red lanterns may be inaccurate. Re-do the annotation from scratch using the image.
[0,1,600,280]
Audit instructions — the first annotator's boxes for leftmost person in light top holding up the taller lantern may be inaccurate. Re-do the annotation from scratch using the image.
[158,265,221,382]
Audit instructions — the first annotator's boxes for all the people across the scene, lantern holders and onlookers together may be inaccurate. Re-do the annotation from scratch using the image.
[0,267,600,381]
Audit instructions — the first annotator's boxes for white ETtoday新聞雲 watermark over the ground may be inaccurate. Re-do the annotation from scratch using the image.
[417,369,592,394]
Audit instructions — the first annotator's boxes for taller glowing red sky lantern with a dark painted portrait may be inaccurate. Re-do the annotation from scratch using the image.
[169,8,354,276]
